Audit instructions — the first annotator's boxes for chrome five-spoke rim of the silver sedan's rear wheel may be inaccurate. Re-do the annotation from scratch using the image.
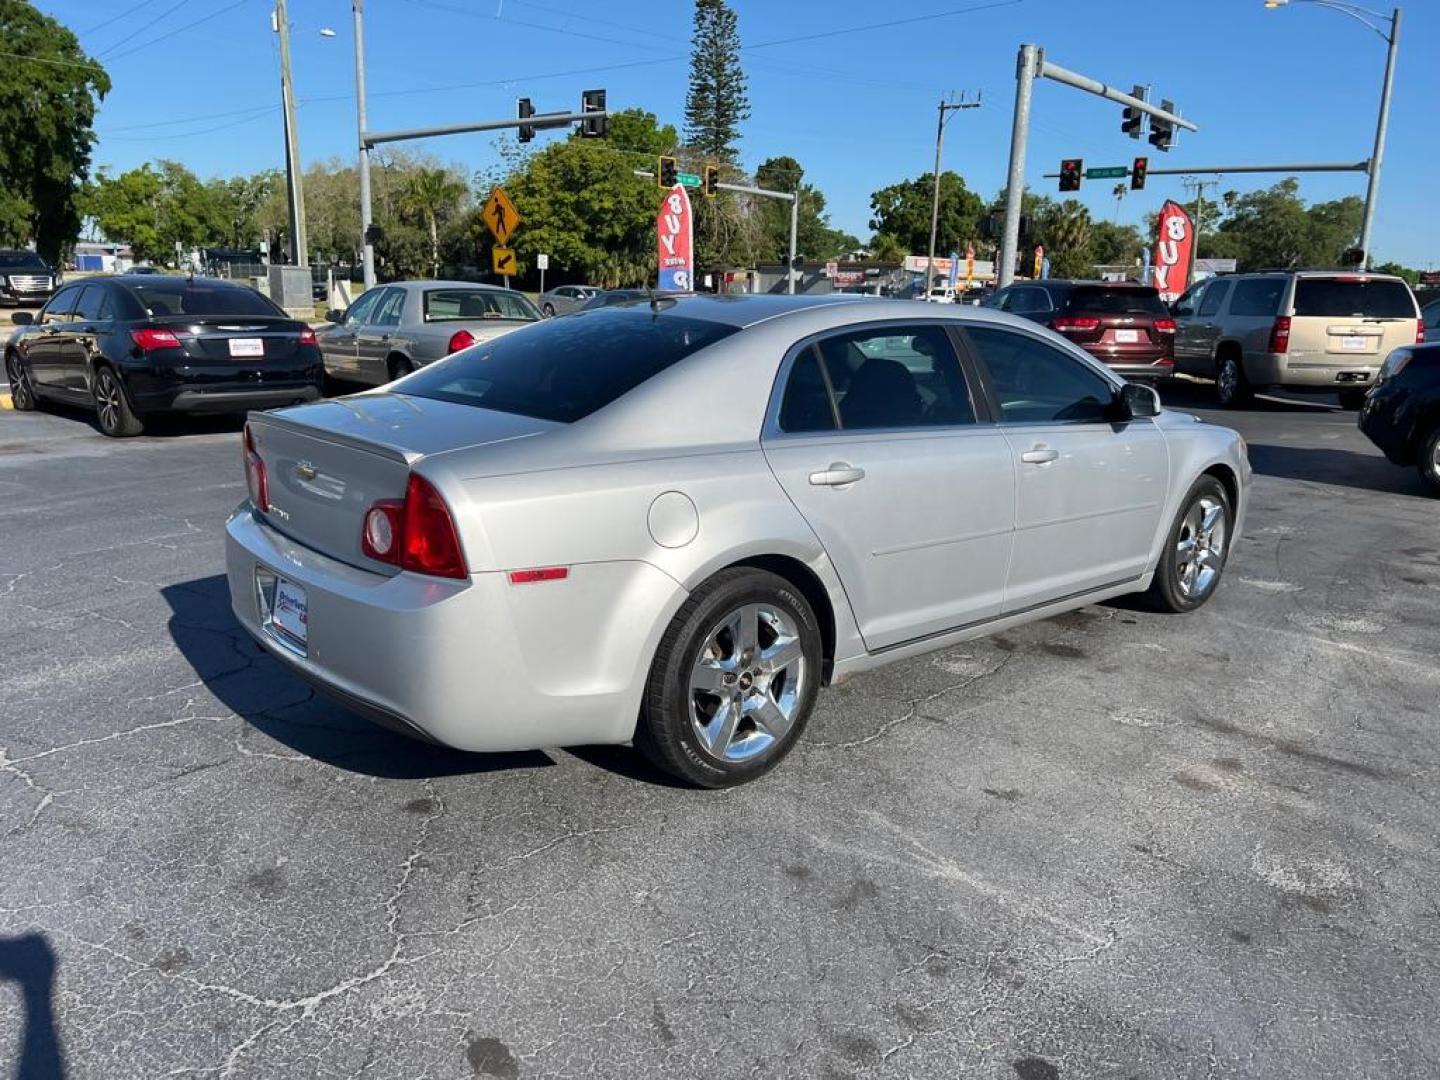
[690,603,809,762]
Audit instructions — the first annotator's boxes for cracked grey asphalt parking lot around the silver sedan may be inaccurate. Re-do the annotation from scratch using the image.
[0,387,1440,1080]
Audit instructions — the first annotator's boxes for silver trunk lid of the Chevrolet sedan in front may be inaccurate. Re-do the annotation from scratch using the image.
[249,393,560,575]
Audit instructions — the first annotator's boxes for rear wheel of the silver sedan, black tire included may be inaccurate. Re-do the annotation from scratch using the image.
[635,566,822,788]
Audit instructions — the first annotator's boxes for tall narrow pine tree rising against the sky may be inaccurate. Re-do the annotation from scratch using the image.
[685,0,750,164]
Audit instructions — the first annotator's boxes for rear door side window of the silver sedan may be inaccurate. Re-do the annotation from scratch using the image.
[780,325,975,432]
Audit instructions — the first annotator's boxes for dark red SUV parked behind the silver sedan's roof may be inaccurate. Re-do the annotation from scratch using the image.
[985,279,1175,380]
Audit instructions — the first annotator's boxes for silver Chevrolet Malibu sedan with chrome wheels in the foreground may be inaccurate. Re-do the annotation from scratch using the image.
[228,295,1250,786]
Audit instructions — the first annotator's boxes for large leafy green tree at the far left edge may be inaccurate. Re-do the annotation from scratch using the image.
[0,0,109,261]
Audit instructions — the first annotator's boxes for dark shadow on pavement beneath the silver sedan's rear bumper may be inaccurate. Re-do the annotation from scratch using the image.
[160,575,554,779]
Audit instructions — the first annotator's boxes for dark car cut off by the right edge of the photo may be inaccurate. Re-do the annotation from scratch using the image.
[1359,343,1440,495]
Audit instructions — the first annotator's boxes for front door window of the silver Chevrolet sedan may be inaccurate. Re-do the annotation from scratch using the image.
[965,325,1115,423]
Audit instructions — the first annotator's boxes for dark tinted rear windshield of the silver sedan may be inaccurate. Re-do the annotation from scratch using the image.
[405,304,737,423]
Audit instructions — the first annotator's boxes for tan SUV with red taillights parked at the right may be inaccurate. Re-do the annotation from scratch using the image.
[1171,271,1424,409]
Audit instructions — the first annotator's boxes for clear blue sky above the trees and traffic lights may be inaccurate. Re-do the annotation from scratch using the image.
[37,0,1440,268]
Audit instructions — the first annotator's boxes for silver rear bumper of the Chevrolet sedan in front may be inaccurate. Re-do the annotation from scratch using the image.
[226,504,685,752]
